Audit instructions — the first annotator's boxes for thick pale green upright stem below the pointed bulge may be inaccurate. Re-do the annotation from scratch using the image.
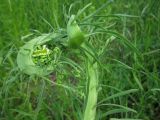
[84,43,98,120]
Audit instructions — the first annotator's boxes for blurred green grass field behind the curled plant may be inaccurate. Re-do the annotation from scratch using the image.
[0,0,160,120]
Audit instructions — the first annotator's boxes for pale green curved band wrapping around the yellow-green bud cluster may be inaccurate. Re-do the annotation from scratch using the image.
[17,33,57,76]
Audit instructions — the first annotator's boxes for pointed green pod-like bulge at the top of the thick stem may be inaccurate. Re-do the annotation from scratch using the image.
[67,15,85,48]
